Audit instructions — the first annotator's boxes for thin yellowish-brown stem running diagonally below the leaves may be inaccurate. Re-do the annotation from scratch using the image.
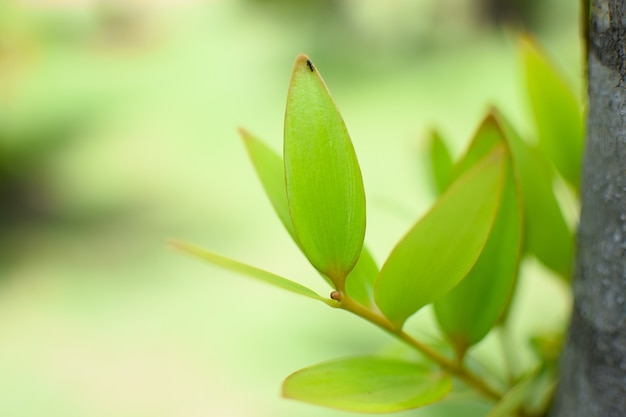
[335,293,502,401]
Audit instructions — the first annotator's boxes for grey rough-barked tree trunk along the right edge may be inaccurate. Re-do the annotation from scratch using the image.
[551,0,626,417]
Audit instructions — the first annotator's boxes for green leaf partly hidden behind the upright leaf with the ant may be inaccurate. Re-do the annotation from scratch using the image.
[239,129,378,307]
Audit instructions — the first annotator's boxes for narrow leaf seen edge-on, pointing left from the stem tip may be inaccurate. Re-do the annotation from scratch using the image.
[172,241,337,307]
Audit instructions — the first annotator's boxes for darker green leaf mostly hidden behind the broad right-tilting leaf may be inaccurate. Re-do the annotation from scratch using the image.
[434,116,522,357]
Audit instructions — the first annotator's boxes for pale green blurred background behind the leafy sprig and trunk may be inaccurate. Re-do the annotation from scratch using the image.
[0,0,583,417]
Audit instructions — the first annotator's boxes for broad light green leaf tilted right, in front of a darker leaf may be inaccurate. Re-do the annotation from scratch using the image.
[375,145,507,327]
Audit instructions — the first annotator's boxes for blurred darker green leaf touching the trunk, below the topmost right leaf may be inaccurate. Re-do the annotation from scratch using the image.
[499,115,574,280]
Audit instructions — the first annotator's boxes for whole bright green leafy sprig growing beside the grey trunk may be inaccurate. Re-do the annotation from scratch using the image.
[174,38,583,417]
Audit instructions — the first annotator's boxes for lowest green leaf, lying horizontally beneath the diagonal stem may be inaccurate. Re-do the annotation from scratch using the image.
[283,357,452,413]
